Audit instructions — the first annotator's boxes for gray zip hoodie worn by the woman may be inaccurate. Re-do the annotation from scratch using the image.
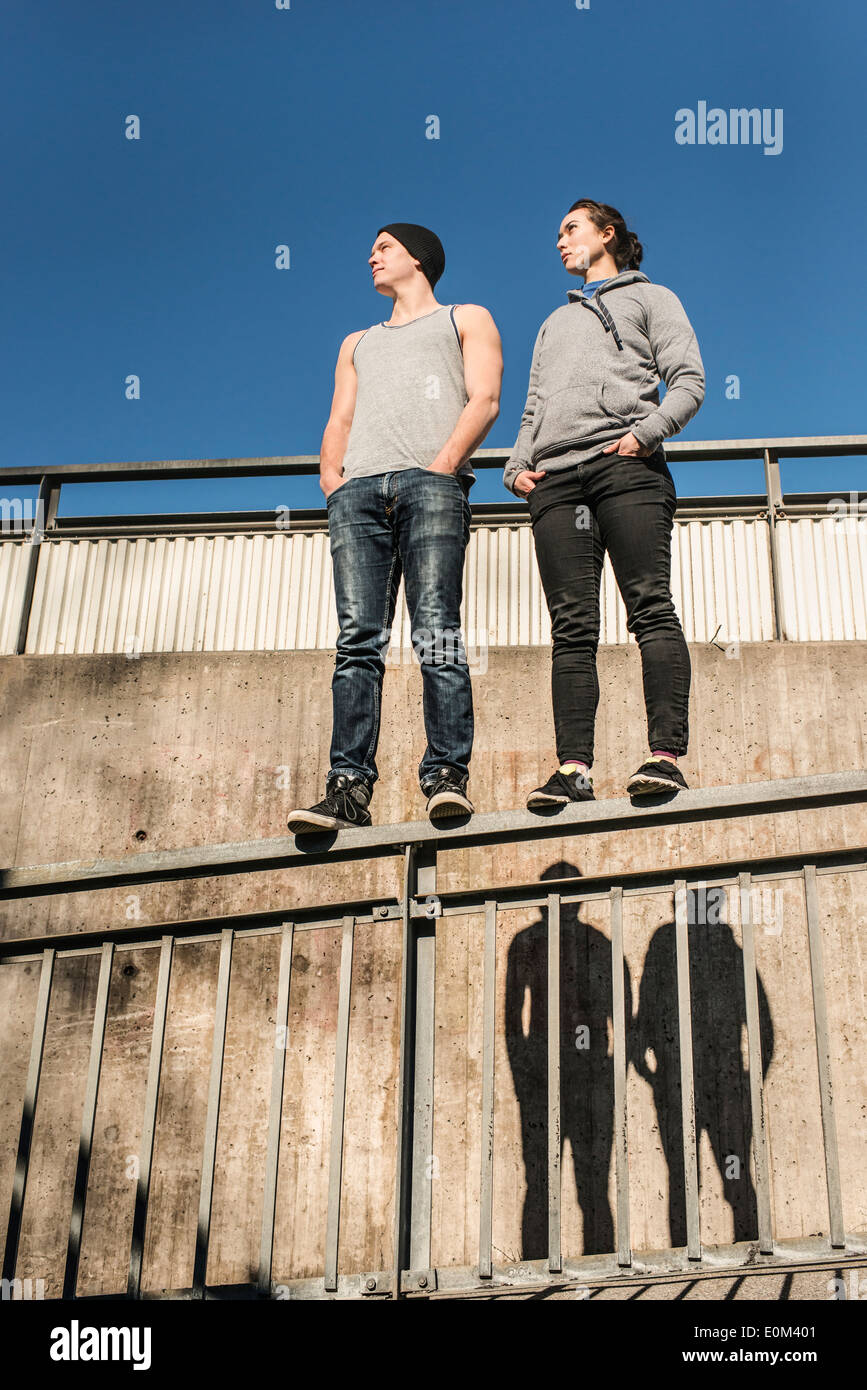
[503,270,704,496]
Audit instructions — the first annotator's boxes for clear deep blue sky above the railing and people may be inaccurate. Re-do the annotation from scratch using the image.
[0,0,867,514]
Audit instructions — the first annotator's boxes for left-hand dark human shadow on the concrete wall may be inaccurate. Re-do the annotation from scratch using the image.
[506,860,631,1259]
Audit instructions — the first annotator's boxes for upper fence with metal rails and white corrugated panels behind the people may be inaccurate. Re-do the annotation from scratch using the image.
[0,435,867,655]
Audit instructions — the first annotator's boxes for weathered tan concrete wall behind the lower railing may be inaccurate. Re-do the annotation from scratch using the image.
[0,642,867,1293]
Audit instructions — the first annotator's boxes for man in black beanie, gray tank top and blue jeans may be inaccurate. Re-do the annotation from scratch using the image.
[288,222,503,834]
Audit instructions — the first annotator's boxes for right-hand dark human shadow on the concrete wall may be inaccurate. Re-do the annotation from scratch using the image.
[629,888,774,1247]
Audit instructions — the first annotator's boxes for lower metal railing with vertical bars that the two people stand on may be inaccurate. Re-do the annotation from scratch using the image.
[0,771,867,1298]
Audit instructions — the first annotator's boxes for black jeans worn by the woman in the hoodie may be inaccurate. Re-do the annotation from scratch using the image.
[527,449,692,766]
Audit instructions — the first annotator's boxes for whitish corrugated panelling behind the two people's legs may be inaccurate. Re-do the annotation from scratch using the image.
[0,517,867,655]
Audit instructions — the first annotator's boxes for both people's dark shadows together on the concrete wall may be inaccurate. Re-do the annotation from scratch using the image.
[506,860,774,1259]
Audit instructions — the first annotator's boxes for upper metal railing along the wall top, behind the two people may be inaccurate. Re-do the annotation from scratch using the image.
[0,435,867,655]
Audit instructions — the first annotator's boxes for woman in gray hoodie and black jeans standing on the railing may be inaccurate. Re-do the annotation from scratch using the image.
[503,197,704,808]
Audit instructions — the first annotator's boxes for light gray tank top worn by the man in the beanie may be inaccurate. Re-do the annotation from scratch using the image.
[343,304,475,487]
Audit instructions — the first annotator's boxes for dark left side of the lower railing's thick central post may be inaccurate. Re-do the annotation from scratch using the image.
[392,845,417,1298]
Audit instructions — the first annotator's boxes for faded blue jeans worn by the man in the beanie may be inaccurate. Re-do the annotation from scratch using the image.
[325,468,474,792]
